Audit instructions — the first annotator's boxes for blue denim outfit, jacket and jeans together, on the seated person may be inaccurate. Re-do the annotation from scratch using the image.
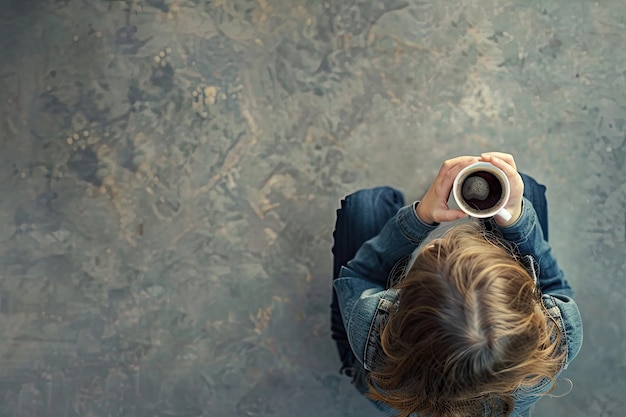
[331,174,582,416]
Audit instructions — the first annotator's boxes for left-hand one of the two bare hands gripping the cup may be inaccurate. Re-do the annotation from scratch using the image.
[416,156,480,224]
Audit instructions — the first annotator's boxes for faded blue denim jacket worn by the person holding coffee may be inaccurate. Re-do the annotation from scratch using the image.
[333,198,583,417]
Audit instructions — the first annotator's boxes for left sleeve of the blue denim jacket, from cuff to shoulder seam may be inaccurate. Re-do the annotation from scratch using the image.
[339,203,438,287]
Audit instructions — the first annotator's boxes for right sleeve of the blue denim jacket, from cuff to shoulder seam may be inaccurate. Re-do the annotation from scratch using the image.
[493,197,574,297]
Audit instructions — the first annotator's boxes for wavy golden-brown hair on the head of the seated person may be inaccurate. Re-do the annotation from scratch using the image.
[367,222,566,417]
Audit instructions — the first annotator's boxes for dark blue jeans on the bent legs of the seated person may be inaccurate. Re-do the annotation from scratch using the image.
[331,173,548,409]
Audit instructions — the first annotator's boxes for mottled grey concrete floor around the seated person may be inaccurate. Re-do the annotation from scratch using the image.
[0,0,626,417]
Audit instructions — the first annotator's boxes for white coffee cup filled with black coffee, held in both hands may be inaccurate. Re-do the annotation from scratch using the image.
[452,162,511,221]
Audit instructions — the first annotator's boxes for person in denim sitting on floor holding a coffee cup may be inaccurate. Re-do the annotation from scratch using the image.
[331,152,582,417]
